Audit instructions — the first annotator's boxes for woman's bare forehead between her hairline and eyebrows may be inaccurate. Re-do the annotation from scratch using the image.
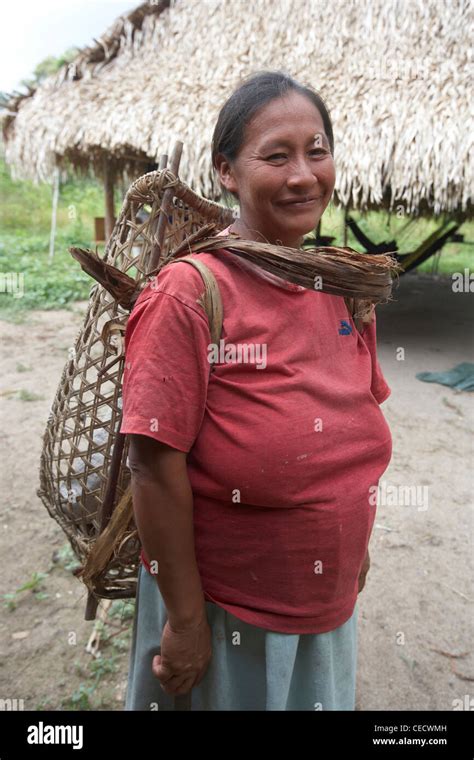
[245,92,329,148]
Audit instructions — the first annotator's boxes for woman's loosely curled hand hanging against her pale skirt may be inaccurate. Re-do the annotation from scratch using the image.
[152,613,212,695]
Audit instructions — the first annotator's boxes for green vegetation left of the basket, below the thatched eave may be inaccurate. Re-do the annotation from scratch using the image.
[0,151,103,321]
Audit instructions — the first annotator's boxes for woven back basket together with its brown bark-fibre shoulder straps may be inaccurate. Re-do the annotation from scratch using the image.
[38,160,398,616]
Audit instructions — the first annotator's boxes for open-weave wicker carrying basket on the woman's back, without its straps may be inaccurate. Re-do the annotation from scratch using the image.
[37,169,234,618]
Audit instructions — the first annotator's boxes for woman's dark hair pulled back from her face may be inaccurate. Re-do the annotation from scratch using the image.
[212,71,334,201]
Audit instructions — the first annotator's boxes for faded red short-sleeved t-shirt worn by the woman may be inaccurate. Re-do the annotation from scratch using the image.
[121,231,392,633]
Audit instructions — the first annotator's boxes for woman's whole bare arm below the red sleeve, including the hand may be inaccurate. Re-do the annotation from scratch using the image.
[129,434,212,695]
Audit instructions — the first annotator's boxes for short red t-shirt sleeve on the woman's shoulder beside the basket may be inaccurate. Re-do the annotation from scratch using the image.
[120,264,211,452]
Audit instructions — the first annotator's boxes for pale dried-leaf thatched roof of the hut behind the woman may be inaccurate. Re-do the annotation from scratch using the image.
[4,0,474,215]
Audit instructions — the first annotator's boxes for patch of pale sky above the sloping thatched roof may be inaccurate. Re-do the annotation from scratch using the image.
[0,0,135,92]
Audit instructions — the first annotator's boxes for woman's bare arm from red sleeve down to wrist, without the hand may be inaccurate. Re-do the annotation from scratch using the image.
[129,435,205,632]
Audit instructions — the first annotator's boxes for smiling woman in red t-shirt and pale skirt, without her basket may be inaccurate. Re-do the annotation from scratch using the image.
[121,72,392,710]
